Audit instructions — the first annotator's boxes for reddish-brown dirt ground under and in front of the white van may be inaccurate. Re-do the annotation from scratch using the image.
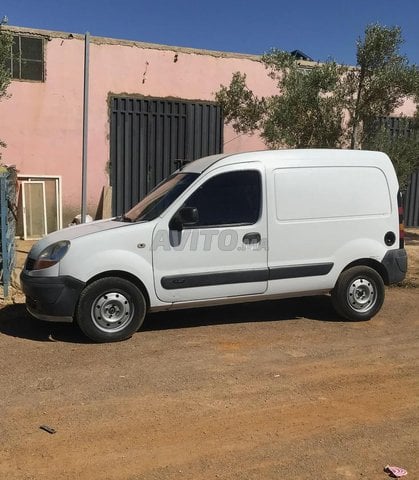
[0,231,419,480]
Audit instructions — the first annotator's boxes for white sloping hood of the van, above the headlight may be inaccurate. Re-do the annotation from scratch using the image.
[29,219,133,258]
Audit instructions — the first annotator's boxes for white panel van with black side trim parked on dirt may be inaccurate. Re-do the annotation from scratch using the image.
[21,149,407,342]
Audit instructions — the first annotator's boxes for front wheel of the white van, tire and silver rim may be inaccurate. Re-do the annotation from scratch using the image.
[76,277,147,343]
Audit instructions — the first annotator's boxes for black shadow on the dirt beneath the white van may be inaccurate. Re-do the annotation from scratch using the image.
[0,295,344,344]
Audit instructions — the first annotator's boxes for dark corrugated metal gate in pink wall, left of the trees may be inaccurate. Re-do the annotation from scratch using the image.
[110,96,223,215]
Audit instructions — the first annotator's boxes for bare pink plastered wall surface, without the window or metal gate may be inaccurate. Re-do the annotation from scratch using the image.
[0,29,275,216]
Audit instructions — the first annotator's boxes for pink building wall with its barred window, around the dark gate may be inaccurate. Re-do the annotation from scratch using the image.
[0,26,413,237]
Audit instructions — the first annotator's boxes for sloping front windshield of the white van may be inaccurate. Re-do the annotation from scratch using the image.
[122,173,199,222]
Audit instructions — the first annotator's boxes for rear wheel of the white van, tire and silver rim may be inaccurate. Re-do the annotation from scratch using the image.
[332,266,385,321]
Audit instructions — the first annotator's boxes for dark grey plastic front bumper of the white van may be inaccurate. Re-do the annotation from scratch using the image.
[20,271,85,322]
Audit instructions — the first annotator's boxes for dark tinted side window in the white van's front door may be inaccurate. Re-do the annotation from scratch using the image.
[184,170,262,227]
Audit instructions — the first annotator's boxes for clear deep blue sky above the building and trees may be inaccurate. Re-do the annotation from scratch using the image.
[0,0,419,65]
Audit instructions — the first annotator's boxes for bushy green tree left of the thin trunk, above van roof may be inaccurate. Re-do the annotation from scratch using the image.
[216,50,346,148]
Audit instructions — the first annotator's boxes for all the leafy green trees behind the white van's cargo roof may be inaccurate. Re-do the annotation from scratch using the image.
[216,24,419,184]
